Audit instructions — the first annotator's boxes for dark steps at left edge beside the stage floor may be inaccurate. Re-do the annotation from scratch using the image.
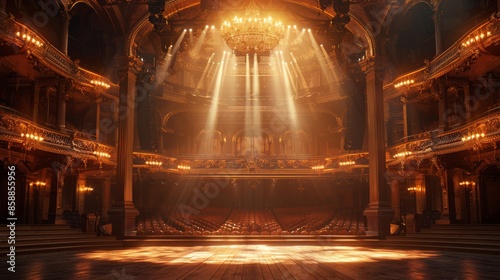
[0,224,122,254]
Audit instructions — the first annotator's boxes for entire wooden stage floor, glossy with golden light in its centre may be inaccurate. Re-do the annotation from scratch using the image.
[0,244,500,280]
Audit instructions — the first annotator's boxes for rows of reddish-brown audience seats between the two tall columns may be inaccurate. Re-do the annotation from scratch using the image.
[137,207,365,235]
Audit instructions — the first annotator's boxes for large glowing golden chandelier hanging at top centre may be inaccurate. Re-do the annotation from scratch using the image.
[221,0,285,55]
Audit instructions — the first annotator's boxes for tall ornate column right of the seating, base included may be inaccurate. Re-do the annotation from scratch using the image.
[363,56,394,236]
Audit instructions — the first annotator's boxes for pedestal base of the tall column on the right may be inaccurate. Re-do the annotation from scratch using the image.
[363,205,394,237]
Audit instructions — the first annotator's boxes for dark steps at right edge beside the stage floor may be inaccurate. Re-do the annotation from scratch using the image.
[381,224,500,254]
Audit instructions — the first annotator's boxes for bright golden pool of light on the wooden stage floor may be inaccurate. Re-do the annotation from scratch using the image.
[79,244,437,265]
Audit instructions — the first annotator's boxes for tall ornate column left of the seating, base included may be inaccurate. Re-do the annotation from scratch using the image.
[108,56,142,238]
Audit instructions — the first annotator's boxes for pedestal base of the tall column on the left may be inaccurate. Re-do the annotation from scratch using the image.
[108,201,139,238]
